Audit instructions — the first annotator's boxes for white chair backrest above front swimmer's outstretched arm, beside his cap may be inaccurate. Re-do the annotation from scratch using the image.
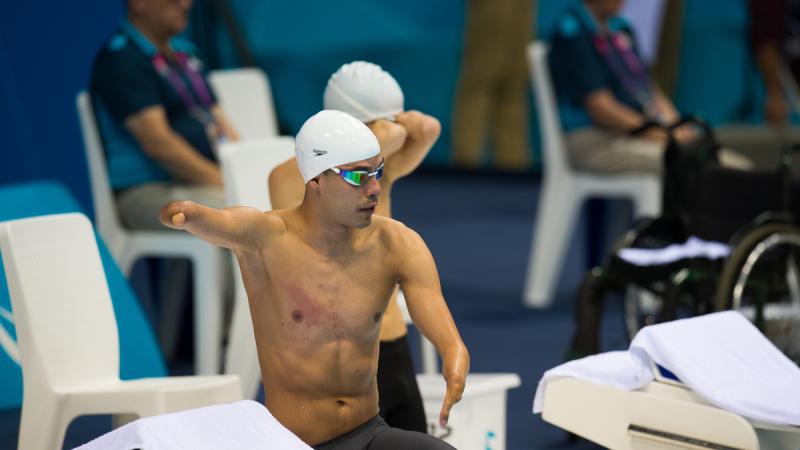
[220,136,294,211]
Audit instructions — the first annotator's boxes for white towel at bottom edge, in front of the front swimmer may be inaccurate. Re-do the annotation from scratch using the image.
[78,400,311,450]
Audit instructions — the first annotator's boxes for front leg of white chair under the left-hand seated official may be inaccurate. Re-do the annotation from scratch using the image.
[193,244,228,375]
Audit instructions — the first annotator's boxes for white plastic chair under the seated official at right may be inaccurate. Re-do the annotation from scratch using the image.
[523,41,661,308]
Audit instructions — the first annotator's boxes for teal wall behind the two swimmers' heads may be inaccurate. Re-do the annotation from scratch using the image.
[200,0,464,165]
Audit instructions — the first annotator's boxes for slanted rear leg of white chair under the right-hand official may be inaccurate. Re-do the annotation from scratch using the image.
[523,181,583,308]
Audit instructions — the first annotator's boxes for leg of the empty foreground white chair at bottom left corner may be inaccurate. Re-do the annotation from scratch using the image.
[17,401,70,450]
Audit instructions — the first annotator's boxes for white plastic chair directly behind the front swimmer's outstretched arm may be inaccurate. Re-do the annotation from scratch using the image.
[220,136,294,398]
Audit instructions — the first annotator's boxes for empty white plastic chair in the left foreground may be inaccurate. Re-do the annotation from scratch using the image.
[0,213,241,450]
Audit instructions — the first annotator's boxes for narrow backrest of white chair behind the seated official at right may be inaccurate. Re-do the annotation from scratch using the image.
[528,41,572,176]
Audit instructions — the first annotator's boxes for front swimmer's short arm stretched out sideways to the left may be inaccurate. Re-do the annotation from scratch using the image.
[159,201,263,251]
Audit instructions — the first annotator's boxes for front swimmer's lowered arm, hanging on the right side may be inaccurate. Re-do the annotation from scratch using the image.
[397,226,469,427]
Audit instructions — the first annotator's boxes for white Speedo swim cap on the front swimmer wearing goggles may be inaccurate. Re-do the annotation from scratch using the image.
[295,110,381,183]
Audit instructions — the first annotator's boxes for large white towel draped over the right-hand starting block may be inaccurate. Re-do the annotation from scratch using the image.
[630,311,800,426]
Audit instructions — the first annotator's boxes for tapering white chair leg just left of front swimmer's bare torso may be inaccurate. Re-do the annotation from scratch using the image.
[225,270,261,399]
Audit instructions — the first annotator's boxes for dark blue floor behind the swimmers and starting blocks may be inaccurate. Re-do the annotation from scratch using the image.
[0,172,627,450]
